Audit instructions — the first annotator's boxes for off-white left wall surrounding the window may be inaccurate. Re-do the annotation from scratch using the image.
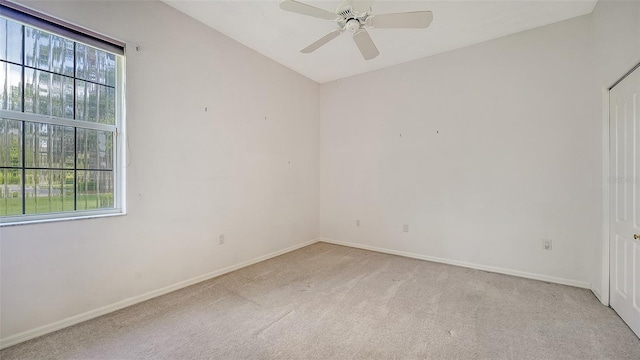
[0,1,319,340]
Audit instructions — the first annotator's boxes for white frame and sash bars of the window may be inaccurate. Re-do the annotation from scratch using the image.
[0,0,127,227]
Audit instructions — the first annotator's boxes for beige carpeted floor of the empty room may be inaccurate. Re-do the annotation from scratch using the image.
[0,243,640,360]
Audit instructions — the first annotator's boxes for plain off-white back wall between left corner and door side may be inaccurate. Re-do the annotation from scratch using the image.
[320,15,602,287]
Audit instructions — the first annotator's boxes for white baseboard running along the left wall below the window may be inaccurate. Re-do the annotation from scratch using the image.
[0,239,320,349]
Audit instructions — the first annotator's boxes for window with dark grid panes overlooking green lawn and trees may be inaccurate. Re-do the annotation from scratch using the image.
[0,6,123,223]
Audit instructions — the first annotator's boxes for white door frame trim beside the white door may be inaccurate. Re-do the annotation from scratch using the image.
[604,63,640,306]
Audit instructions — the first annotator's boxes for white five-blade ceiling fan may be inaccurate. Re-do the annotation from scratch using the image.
[280,0,433,60]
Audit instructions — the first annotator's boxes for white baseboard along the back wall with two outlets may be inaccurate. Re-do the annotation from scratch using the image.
[319,238,591,289]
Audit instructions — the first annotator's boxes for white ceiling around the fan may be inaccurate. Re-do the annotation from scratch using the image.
[164,0,597,83]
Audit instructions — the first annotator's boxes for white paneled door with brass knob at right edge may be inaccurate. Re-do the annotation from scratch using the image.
[609,64,640,336]
